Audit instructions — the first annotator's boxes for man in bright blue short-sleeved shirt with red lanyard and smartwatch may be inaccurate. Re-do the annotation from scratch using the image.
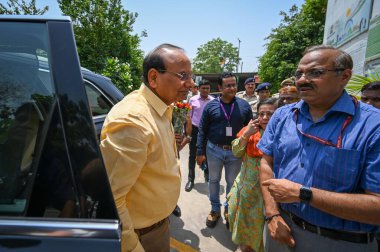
[258,45,380,252]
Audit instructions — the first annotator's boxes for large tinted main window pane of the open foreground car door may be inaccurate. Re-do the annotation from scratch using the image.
[0,22,55,215]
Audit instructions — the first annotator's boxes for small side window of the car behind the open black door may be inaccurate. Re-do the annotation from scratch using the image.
[85,81,113,116]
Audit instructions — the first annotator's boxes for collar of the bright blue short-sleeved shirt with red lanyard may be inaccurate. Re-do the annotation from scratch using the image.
[292,90,355,116]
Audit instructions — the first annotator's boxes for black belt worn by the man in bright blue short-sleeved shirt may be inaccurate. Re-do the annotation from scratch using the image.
[282,209,375,243]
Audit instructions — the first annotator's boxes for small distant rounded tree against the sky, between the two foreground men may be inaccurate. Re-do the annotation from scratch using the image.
[193,38,239,73]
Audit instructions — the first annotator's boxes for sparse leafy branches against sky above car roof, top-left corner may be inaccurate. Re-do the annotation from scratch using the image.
[0,0,49,15]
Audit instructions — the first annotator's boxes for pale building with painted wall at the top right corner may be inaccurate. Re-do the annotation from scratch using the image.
[323,0,380,75]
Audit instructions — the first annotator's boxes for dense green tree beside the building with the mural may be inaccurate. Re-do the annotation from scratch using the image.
[259,0,327,89]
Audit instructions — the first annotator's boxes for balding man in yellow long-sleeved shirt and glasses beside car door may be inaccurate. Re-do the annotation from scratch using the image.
[100,44,194,251]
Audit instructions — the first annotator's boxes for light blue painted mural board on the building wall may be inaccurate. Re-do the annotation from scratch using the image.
[323,0,372,47]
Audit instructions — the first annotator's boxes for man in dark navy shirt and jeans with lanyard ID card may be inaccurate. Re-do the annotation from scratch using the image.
[197,73,252,228]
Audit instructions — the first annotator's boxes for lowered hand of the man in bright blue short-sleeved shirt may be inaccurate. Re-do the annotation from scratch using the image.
[268,216,296,247]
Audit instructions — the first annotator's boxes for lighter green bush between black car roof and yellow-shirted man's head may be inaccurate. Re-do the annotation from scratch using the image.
[101,58,134,94]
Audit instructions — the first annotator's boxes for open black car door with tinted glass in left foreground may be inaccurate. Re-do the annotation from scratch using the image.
[0,16,122,252]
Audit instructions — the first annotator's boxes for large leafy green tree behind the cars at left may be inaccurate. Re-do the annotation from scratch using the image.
[58,0,146,92]
